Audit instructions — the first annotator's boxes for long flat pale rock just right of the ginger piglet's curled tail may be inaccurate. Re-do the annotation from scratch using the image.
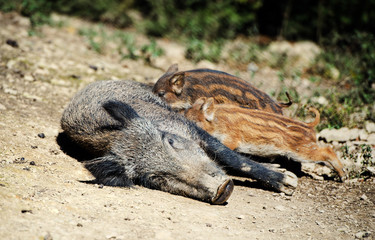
[319,127,359,142]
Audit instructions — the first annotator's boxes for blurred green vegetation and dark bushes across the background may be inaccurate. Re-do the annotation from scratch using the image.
[0,0,375,129]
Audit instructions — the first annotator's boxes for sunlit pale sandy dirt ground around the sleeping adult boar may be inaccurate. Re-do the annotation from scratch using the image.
[0,13,375,239]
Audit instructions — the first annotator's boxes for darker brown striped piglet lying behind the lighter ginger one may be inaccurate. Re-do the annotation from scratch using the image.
[153,64,292,114]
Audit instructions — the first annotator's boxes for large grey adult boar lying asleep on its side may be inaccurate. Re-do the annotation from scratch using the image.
[61,80,297,204]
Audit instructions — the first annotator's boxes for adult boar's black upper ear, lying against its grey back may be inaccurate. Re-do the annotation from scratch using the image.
[103,101,139,127]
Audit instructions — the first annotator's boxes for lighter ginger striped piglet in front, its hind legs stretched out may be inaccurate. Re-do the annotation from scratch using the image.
[185,98,345,179]
